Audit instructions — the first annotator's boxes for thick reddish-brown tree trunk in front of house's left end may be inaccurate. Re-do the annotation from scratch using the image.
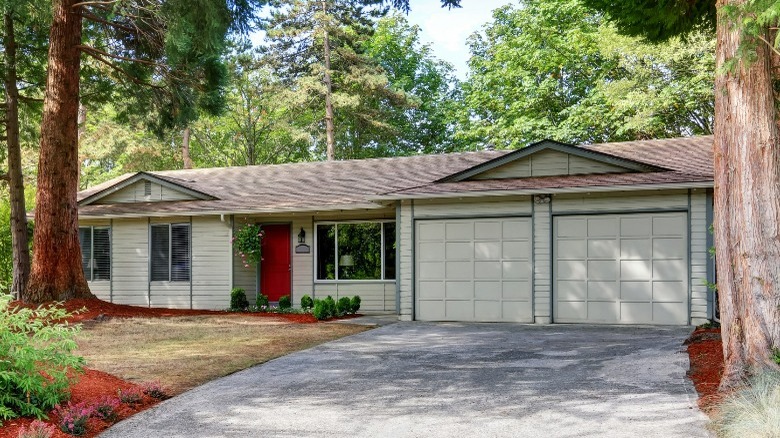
[24,0,94,303]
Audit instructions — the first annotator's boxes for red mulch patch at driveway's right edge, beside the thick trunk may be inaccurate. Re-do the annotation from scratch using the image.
[685,328,723,412]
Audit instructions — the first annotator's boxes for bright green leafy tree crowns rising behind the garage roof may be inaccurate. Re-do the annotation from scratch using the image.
[456,0,715,148]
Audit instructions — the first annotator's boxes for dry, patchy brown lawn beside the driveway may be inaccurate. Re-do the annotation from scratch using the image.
[76,316,366,395]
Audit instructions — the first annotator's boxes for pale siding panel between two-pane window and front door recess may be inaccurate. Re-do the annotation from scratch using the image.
[192,216,232,309]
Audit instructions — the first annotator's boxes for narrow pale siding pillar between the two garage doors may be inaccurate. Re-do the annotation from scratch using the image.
[533,199,552,324]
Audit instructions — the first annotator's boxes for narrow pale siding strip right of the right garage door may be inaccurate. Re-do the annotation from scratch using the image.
[690,190,710,325]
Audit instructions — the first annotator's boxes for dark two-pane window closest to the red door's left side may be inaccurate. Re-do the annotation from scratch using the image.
[150,224,190,281]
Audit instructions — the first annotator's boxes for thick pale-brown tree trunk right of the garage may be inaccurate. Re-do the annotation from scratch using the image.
[714,0,780,390]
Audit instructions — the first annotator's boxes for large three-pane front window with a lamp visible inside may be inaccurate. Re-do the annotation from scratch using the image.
[316,221,395,280]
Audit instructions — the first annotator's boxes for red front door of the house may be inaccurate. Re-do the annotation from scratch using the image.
[260,224,290,301]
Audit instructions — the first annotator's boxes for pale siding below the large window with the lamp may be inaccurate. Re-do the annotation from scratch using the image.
[314,281,395,313]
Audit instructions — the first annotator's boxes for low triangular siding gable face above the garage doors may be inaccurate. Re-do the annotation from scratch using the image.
[469,149,629,180]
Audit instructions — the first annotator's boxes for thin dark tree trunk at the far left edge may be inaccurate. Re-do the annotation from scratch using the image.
[3,12,30,297]
